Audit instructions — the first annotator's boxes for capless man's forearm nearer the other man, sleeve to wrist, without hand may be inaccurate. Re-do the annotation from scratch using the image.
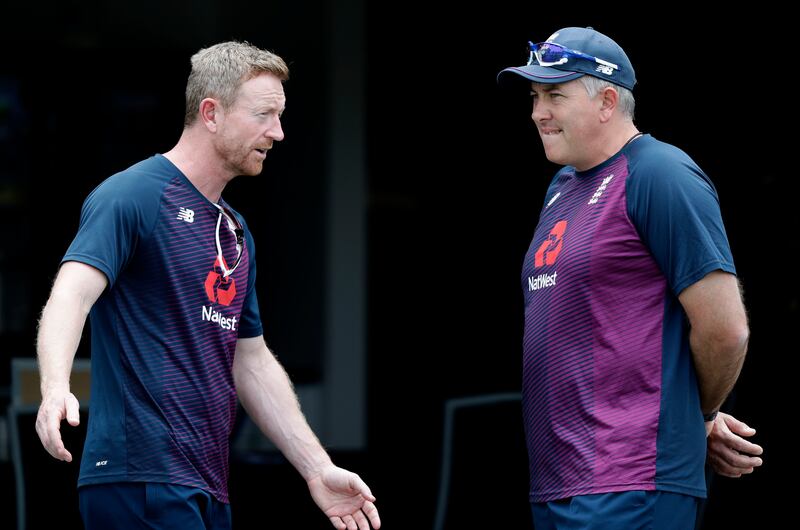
[233,341,331,480]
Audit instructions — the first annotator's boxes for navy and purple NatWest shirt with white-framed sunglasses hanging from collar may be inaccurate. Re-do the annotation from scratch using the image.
[63,155,262,502]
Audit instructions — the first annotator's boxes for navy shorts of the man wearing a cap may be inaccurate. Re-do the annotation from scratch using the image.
[531,491,701,530]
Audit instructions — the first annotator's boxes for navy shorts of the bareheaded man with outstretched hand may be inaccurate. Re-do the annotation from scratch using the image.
[78,482,231,530]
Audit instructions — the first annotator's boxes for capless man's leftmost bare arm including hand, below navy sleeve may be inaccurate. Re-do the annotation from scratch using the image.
[36,261,108,462]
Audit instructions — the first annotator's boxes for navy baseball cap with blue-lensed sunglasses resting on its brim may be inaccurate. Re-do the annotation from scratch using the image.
[497,28,636,90]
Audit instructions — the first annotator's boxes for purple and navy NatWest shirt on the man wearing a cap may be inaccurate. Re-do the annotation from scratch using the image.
[522,135,736,502]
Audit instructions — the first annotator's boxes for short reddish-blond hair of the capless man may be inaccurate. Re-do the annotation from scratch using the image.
[183,41,289,127]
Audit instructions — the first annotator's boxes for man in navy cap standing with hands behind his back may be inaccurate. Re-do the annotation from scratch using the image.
[499,27,761,530]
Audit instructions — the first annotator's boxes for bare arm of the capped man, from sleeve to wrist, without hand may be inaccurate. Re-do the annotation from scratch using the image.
[678,270,750,414]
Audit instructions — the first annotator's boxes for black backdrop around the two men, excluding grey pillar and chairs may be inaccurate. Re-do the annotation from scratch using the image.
[0,0,800,528]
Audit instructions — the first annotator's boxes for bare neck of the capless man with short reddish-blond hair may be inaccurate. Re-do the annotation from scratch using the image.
[164,127,233,203]
